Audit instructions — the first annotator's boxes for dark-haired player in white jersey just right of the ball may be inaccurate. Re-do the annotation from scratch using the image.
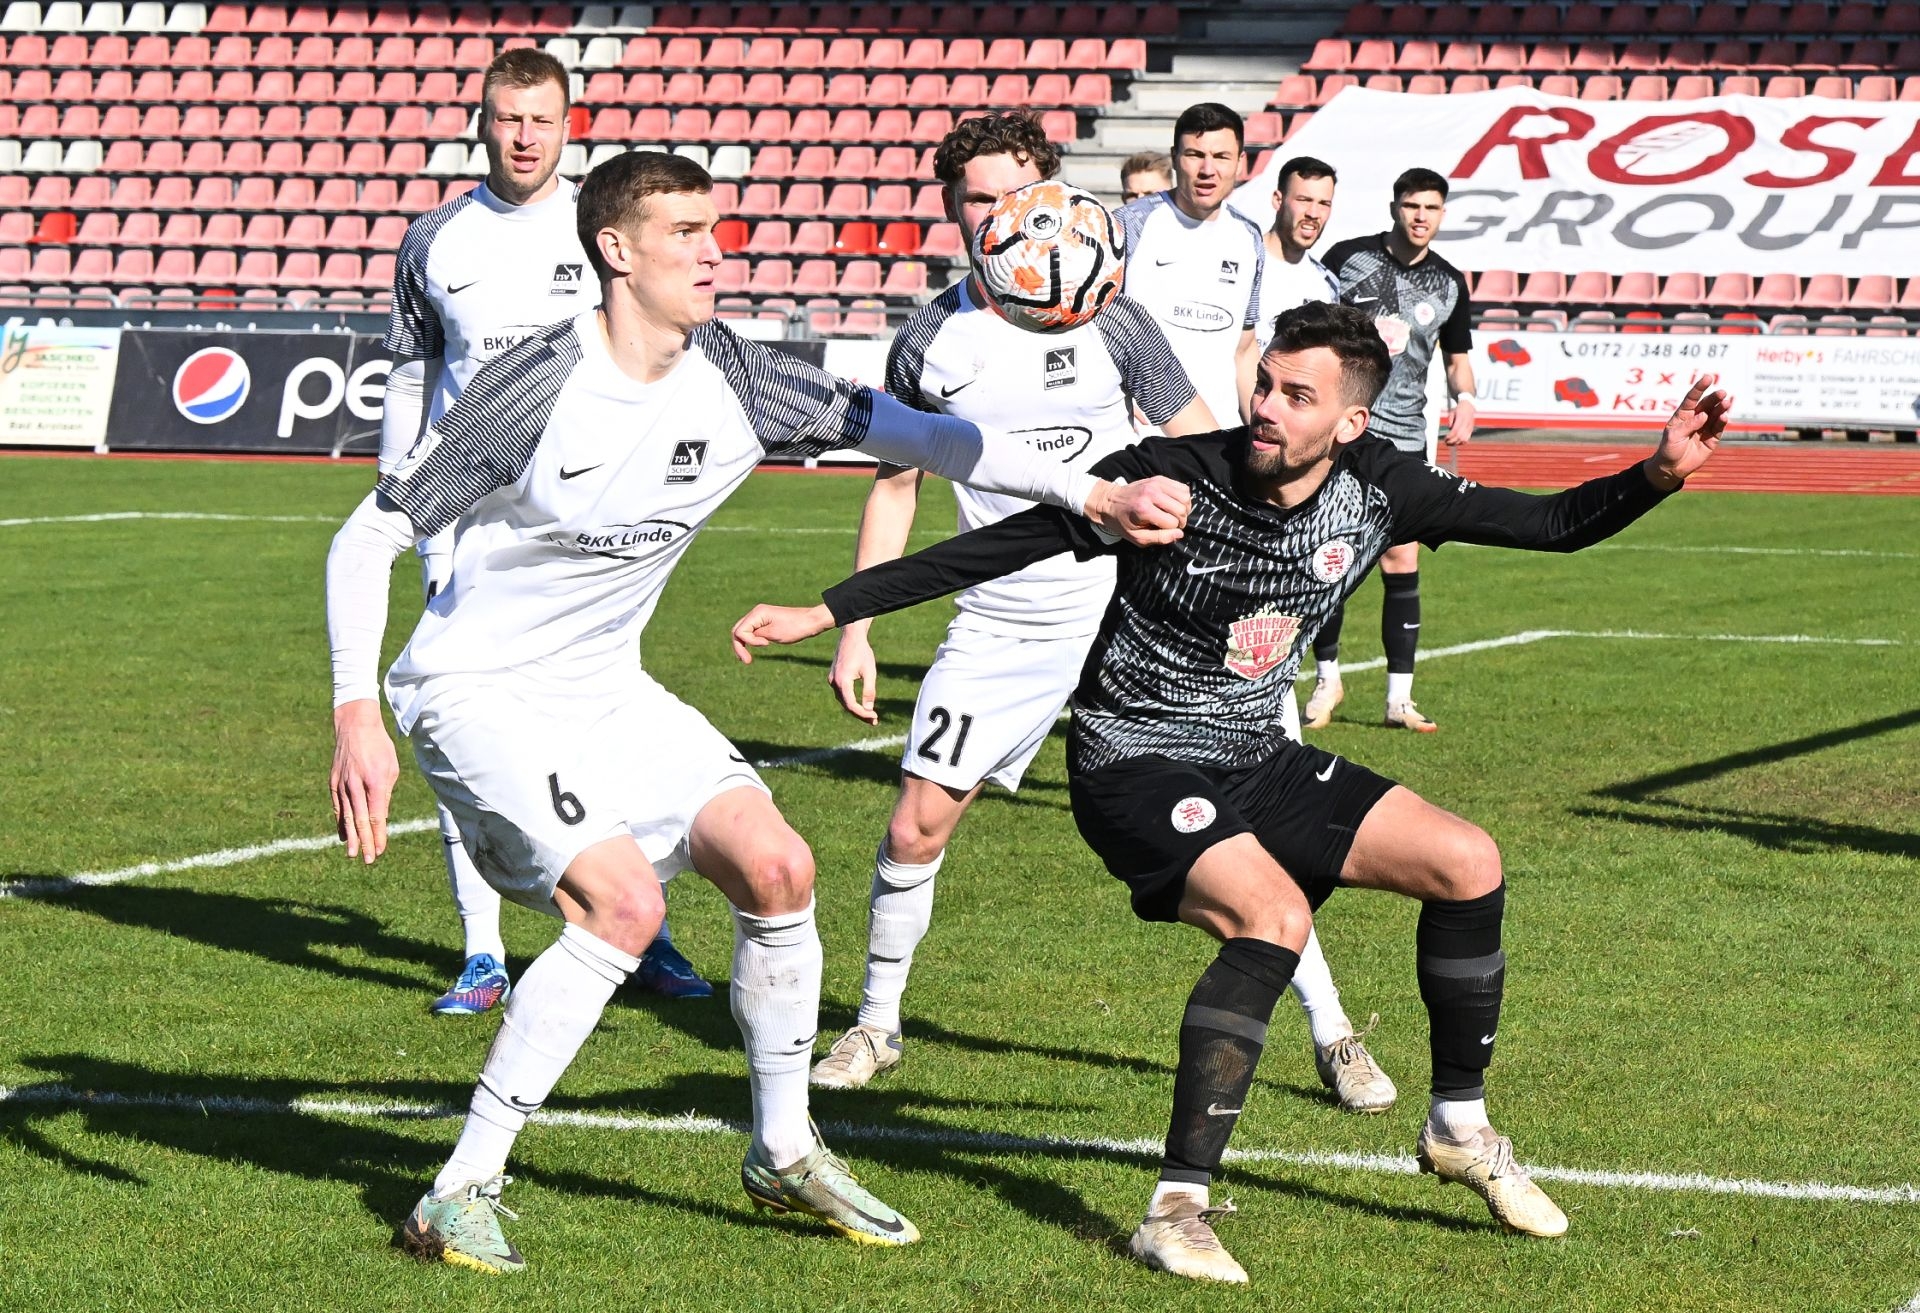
[1117,104,1265,424]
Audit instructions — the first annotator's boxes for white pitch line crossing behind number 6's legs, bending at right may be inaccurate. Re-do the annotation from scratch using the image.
[0,630,1920,902]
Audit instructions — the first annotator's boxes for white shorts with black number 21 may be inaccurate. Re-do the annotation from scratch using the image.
[900,616,1094,793]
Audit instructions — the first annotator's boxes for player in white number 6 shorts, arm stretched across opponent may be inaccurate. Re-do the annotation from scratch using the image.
[326,152,1187,1273]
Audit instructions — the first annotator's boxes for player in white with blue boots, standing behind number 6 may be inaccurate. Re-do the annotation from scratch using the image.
[380,48,712,1017]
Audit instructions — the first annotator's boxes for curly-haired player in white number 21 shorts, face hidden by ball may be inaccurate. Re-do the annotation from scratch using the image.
[812,113,1396,1111]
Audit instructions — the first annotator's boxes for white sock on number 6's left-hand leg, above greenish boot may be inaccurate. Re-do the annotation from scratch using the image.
[434,925,639,1198]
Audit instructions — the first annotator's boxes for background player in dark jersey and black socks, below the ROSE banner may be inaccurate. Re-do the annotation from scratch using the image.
[1306,169,1473,733]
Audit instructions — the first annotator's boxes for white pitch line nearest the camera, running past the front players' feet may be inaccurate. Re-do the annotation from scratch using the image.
[0,1085,1920,1204]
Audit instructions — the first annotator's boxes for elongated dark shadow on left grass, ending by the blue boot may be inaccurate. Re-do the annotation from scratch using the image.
[24,885,459,992]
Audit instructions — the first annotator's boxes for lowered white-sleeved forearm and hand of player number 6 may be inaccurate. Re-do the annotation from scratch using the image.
[326,493,417,862]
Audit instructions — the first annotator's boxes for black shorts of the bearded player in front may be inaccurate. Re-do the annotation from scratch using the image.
[1069,739,1394,921]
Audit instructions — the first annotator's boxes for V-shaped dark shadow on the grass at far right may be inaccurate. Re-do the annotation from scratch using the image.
[1572,710,1920,856]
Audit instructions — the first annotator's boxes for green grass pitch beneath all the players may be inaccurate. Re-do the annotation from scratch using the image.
[0,459,1920,1313]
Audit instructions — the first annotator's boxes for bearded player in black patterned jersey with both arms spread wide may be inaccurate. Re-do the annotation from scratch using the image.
[733,303,1730,1282]
